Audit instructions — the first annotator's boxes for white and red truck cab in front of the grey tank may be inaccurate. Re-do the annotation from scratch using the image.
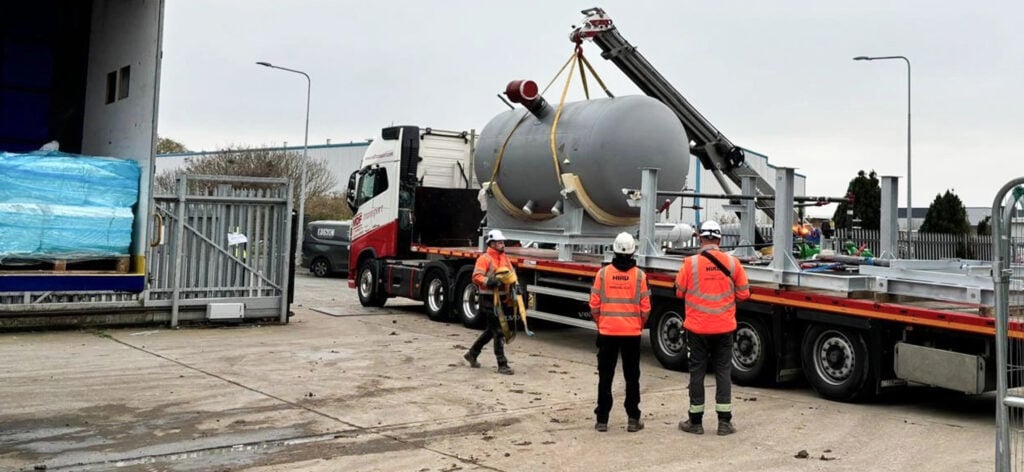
[346,126,482,303]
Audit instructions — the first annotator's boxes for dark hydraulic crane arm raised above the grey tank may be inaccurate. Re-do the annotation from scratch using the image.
[569,8,775,218]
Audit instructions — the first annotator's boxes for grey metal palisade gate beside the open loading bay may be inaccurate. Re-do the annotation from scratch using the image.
[145,175,292,327]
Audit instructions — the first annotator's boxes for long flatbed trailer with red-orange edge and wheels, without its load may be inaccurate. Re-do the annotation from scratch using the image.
[403,239,1024,400]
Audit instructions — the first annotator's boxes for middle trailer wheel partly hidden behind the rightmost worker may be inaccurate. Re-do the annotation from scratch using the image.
[732,313,775,385]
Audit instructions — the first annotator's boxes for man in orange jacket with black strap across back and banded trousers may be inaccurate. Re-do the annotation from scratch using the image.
[676,221,751,436]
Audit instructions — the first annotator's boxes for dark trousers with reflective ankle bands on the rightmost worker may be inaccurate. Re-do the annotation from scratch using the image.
[686,332,733,422]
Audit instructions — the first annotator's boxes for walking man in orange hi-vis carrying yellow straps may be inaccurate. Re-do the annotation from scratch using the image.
[463,229,515,376]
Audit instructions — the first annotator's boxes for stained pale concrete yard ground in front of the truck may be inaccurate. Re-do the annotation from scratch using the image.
[0,273,995,472]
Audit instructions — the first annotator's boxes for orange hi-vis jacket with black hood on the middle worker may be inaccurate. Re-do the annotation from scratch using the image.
[590,265,650,336]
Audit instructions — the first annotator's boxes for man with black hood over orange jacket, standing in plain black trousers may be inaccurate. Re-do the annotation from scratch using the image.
[590,232,650,433]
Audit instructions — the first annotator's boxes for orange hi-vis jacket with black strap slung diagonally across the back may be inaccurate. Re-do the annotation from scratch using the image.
[676,247,751,335]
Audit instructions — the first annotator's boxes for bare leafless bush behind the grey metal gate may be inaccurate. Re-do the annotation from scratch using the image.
[154,146,335,219]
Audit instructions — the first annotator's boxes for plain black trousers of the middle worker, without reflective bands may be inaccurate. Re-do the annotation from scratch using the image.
[594,335,640,423]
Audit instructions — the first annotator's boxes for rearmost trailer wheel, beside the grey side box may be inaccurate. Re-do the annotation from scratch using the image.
[801,325,872,401]
